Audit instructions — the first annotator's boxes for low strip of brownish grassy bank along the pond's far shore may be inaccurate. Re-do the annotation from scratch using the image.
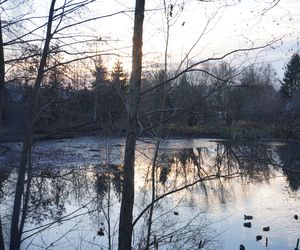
[0,121,300,142]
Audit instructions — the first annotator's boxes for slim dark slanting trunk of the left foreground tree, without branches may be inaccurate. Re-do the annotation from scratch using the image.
[10,0,56,250]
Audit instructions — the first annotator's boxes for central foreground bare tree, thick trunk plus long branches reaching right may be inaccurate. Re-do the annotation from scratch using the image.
[119,0,282,249]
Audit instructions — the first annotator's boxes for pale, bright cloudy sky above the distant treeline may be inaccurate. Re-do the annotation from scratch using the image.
[11,0,300,78]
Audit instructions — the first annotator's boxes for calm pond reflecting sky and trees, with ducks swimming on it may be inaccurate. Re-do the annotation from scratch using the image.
[0,137,300,250]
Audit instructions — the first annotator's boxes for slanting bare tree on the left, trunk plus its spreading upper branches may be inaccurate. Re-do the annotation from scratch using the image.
[5,0,135,249]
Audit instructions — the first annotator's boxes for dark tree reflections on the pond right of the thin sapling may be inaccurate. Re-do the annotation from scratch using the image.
[154,141,300,209]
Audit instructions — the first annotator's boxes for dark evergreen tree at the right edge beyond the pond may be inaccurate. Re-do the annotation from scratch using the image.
[280,54,300,98]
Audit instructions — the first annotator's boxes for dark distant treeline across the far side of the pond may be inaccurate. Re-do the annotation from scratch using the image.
[1,54,300,141]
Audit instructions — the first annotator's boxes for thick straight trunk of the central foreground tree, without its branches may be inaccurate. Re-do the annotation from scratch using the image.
[118,0,145,250]
